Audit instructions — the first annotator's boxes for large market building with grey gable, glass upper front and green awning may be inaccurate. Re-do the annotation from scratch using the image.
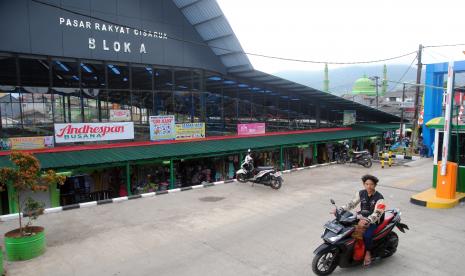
[0,0,399,213]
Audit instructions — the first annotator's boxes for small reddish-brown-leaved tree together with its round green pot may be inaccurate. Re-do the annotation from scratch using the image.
[0,152,65,261]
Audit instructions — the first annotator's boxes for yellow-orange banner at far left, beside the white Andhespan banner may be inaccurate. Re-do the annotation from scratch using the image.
[0,136,54,150]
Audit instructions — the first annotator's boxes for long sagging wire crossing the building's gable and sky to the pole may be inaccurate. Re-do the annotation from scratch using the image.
[31,0,416,65]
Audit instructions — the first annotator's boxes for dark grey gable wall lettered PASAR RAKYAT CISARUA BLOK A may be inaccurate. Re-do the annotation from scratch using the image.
[0,0,225,74]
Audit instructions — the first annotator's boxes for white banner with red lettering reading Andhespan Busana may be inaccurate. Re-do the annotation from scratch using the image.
[55,122,134,143]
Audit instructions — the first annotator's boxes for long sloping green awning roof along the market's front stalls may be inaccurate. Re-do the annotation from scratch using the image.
[0,129,381,169]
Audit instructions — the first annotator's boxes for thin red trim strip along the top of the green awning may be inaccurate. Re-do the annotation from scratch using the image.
[0,127,352,156]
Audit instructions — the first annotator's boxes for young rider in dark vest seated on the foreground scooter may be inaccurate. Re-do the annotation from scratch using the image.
[332,174,386,266]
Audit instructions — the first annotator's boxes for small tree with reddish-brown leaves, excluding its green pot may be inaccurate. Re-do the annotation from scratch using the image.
[0,152,65,236]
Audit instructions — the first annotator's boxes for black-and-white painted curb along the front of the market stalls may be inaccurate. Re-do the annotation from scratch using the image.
[0,162,336,222]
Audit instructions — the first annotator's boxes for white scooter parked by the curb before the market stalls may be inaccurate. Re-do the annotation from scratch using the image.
[236,161,283,190]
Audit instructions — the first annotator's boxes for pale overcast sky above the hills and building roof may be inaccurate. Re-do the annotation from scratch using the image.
[217,0,465,73]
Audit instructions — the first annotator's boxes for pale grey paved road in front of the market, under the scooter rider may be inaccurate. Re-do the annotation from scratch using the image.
[0,159,465,276]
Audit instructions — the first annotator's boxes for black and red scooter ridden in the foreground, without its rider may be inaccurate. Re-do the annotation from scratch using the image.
[312,199,409,275]
